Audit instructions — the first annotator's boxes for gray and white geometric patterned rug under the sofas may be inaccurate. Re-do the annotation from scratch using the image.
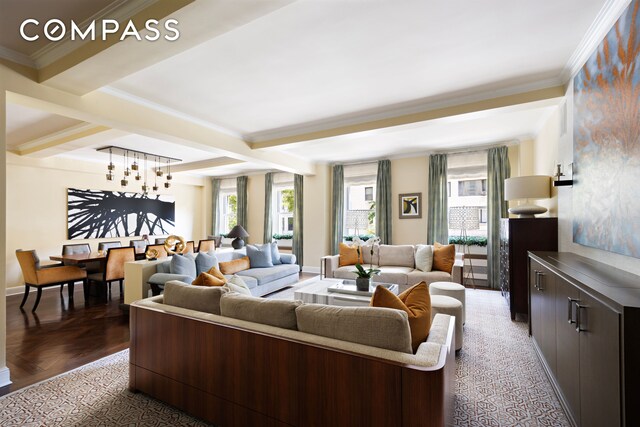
[0,285,569,427]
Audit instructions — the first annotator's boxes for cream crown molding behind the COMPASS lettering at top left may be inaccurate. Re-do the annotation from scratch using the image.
[31,0,158,69]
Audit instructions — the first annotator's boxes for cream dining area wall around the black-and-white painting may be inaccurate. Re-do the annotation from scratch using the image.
[5,153,207,287]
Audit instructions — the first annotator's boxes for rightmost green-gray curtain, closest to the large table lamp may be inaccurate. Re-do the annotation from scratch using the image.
[487,147,511,289]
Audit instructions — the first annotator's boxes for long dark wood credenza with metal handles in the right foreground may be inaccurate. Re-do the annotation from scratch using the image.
[528,252,640,427]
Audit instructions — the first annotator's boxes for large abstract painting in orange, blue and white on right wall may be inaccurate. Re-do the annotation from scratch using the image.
[573,0,640,258]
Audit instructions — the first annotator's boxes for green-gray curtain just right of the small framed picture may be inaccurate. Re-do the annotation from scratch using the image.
[427,154,449,245]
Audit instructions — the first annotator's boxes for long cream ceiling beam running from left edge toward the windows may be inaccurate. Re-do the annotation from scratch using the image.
[0,65,315,175]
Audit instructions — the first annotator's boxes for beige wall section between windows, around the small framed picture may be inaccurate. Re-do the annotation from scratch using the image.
[391,156,429,245]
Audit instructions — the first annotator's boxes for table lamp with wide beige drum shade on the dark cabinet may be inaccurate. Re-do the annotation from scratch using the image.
[504,175,551,218]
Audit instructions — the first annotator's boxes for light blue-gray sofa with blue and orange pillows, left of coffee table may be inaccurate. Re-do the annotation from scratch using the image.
[148,248,300,296]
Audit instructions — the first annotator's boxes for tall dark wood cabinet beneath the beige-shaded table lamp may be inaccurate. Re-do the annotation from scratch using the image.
[500,218,558,320]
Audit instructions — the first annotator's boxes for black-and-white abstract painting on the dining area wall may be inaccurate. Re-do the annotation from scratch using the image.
[67,188,176,239]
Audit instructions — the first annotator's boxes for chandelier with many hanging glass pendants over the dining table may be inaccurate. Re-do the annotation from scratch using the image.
[96,145,182,194]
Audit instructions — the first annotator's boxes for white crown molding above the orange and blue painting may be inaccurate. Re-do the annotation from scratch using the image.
[561,0,631,83]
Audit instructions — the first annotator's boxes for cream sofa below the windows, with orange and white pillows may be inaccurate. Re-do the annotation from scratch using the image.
[321,245,464,292]
